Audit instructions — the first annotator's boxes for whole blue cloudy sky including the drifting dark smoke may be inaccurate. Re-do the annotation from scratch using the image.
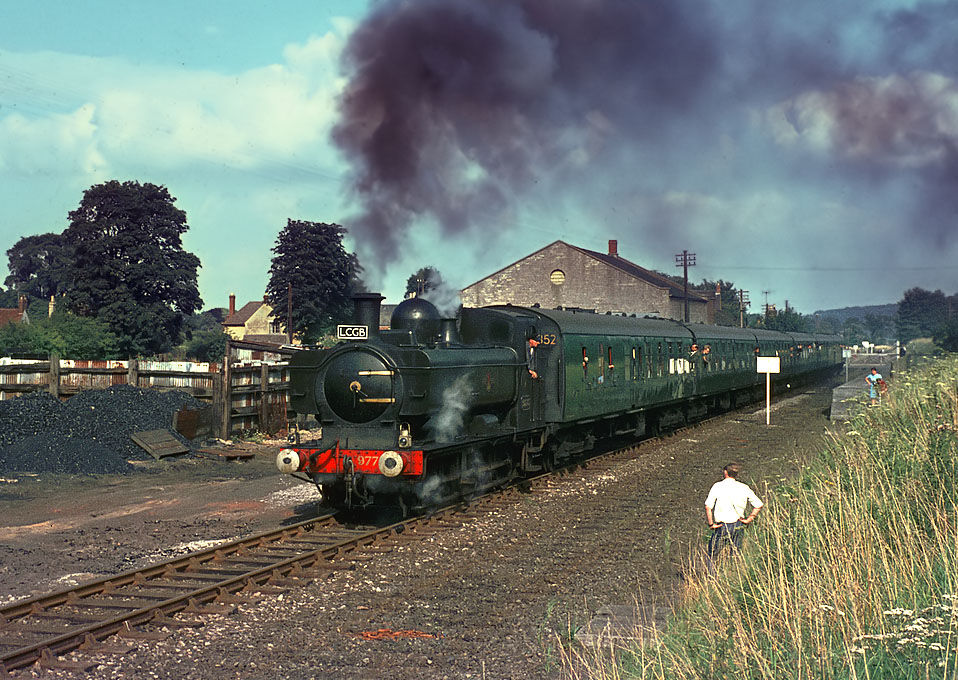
[0,0,958,313]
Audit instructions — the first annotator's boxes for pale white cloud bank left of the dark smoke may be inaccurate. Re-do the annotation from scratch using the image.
[0,26,352,175]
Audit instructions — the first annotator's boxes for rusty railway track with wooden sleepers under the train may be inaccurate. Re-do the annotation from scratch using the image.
[0,386,816,678]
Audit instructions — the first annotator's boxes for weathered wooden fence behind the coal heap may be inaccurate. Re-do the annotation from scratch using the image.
[0,342,290,439]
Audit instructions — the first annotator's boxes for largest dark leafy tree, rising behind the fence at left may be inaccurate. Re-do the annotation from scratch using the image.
[63,180,202,356]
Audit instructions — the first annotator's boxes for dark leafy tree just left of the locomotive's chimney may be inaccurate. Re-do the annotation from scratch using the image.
[266,220,363,344]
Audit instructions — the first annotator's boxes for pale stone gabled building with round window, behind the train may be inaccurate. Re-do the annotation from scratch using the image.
[461,240,714,323]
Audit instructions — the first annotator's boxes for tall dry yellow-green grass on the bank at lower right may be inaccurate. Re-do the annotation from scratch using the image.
[563,358,958,680]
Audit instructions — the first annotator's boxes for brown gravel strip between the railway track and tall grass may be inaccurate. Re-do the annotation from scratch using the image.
[0,389,830,680]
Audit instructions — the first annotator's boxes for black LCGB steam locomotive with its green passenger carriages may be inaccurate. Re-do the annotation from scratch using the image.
[276,294,842,512]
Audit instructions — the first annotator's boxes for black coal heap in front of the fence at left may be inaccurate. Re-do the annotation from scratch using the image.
[0,385,204,475]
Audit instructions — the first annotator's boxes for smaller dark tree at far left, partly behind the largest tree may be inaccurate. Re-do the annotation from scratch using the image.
[4,233,73,300]
